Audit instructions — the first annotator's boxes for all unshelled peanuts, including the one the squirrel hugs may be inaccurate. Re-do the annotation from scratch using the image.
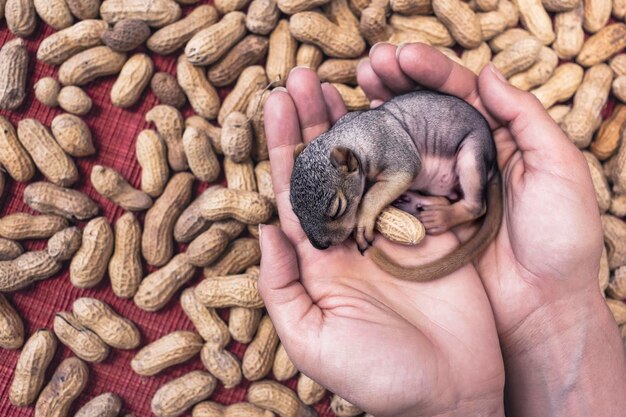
[0,0,626,417]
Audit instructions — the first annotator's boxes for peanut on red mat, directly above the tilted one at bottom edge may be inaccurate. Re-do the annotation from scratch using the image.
[130,330,203,376]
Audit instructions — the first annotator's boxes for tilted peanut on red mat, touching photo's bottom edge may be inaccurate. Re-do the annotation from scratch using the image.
[151,371,217,417]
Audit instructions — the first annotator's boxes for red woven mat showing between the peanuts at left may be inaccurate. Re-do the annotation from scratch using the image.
[0,1,333,417]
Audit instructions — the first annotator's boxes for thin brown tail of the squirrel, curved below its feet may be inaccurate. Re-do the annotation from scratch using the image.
[368,172,503,282]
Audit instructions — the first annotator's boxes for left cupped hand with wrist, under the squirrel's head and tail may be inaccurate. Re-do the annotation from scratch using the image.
[259,68,504,417]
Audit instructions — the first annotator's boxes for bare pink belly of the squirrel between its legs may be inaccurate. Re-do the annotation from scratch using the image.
[411,155,459,199]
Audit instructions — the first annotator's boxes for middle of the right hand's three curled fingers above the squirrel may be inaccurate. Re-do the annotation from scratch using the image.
[370,43,415,94]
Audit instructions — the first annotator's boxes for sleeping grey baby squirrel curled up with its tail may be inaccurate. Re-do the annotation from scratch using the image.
[290,90,502,281]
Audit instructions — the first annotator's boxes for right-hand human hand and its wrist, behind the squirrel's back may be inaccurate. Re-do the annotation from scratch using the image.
[358,40,624,416]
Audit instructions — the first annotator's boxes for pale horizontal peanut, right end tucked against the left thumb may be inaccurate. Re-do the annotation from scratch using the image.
[195,274,263,308]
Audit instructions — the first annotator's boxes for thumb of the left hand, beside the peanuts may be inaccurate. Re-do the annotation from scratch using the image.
[258,226,322,357]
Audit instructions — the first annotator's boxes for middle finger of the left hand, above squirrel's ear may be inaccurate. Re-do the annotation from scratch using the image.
[287,67,330,143]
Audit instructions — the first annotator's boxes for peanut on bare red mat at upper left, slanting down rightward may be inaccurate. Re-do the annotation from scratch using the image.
[91,165,152,211]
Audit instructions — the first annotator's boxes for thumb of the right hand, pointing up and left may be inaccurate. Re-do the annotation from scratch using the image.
[478,64,576,167]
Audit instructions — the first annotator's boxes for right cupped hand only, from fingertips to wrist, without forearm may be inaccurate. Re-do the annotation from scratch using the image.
[358,44,603,346]
